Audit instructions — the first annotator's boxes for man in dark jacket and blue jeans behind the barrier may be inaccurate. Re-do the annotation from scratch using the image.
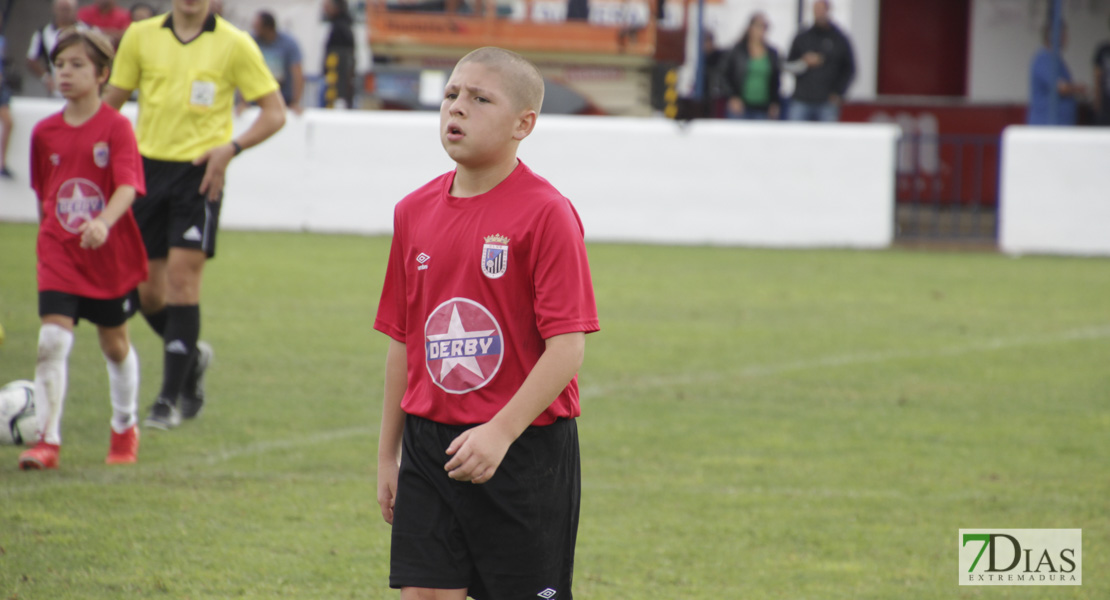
[787,0,856,122]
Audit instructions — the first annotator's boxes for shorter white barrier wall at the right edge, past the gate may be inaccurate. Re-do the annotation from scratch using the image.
[999,126,1110,255]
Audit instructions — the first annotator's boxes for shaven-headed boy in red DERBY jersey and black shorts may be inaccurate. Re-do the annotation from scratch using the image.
[374,48,598,600]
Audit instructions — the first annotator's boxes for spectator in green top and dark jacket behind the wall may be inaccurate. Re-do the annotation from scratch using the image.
[719,12,783,121]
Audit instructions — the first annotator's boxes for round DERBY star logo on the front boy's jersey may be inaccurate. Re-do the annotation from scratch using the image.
[424,298,504,394]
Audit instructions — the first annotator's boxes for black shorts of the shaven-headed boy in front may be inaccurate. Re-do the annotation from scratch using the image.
[390,415,582,600]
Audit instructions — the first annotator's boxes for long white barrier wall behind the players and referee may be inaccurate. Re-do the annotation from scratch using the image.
[0,98,898,247]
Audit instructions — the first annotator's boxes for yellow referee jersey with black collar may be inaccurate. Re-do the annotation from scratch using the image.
[109,13,278,162]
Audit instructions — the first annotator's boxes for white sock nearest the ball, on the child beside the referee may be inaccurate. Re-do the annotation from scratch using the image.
[34,323,73,445]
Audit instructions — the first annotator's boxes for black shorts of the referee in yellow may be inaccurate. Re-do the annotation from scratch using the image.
[132,156,223,258]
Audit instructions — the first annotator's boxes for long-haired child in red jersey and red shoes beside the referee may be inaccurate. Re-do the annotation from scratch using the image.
[19,31,147,469]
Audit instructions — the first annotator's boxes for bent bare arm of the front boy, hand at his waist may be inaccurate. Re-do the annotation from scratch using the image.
[444,332,586,484]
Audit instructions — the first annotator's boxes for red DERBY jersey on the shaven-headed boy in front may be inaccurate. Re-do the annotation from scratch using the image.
[374,163,598,425]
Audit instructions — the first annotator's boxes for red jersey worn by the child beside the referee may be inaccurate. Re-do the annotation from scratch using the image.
[31,104,147,299]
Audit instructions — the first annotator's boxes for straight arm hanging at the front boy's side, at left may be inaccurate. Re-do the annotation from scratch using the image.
[377,338,408,525]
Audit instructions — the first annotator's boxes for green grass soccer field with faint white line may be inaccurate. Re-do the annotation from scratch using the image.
[0,224,1110,600]
